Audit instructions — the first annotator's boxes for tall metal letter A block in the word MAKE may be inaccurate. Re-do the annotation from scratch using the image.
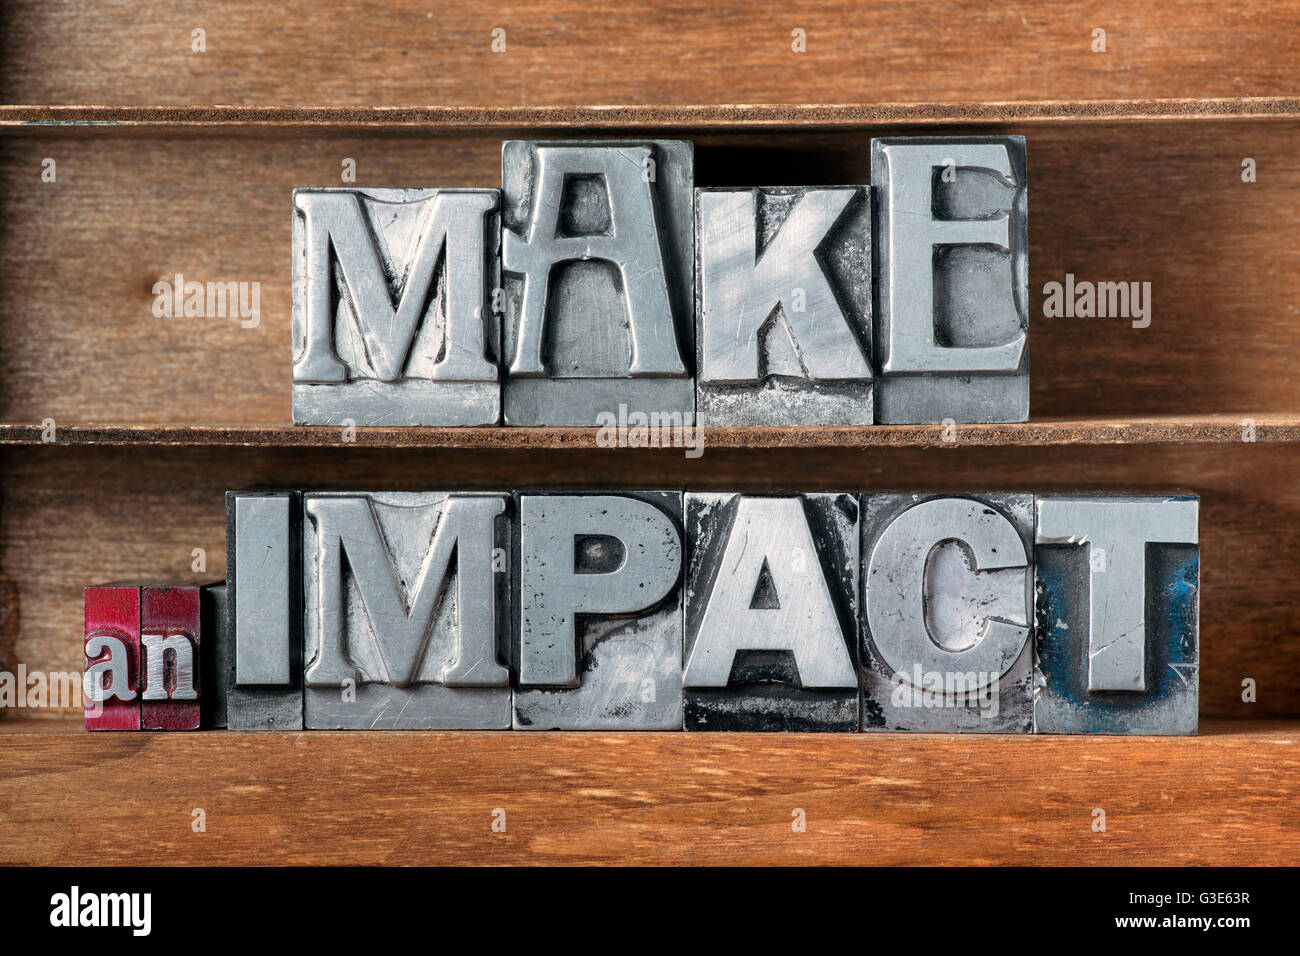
[502,139,696,425]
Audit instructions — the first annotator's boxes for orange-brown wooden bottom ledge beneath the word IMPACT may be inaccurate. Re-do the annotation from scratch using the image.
[0,719,1300,865]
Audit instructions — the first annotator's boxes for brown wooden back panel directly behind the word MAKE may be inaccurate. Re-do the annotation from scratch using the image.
[0,120,1300,425]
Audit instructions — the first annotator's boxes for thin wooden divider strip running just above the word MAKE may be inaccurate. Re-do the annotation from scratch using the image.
[0,96,1300,128]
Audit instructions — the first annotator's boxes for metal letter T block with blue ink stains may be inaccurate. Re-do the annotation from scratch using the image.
[1034,496,1200,735]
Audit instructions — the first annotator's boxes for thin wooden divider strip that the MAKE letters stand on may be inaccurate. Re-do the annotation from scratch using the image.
[0,415,1300,454]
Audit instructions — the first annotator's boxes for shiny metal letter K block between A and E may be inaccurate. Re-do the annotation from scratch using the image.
[696,186,874,425]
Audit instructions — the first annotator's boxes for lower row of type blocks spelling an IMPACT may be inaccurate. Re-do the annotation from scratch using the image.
[85,490,1200,735]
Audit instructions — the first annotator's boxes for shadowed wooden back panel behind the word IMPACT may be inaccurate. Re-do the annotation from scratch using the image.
[0,441,1300,718]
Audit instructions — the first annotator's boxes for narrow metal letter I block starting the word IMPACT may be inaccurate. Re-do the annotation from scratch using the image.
[220,492,303,730]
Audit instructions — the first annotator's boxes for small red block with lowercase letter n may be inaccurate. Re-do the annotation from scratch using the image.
[140,587,199,730]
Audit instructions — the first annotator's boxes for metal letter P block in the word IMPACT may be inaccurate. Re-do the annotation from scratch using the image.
[514,492,683,730]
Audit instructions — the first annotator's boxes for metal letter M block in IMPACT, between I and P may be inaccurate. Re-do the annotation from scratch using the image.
[303,492,511,730]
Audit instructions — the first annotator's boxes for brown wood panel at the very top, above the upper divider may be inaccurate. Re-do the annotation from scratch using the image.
[0,0,1300,107]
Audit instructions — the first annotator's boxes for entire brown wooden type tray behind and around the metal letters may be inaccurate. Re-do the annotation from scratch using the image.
[0,0,1300,865]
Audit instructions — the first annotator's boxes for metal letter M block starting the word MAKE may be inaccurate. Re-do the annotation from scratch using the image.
[294,189,501,425]
